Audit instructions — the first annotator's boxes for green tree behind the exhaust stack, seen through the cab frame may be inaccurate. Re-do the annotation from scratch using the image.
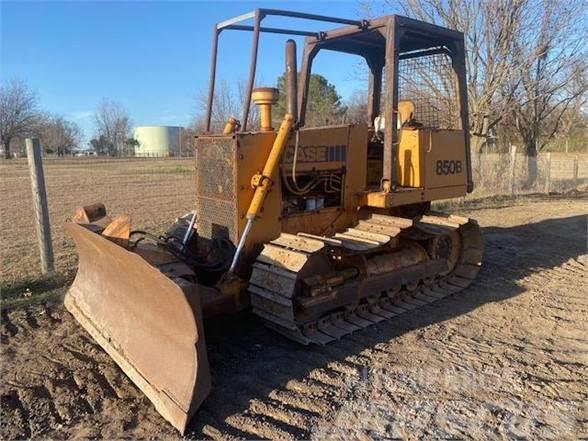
[273,74,347,127]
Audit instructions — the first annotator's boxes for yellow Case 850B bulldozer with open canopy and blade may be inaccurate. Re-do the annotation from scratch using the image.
[65,9,483,433]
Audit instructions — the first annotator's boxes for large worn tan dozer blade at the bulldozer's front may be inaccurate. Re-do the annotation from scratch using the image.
[65,222,211,433]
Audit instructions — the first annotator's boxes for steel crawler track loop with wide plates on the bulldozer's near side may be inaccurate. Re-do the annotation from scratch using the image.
[249,213,484,345]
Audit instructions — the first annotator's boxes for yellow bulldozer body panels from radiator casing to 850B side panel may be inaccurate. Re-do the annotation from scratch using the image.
[196,124,466,260]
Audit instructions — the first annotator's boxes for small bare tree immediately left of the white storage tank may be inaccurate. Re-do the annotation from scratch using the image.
[90,99,132,156]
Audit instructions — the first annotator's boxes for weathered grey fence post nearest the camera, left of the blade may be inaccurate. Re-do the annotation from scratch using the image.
[26,138,53,274]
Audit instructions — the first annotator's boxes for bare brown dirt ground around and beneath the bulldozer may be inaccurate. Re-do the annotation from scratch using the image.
[0,197,588,439]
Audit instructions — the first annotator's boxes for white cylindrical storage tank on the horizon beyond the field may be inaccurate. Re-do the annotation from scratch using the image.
[133,126,182,158]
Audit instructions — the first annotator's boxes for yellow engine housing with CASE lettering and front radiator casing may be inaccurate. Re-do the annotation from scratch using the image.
[196,125,368,258]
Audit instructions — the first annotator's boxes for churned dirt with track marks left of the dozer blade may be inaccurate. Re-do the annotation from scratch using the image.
[0,300,173,439]
